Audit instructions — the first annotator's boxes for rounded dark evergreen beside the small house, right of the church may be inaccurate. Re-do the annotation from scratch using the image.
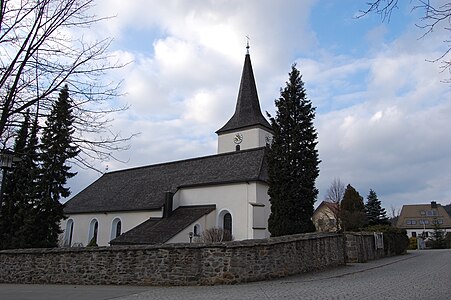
[340,184,367,231]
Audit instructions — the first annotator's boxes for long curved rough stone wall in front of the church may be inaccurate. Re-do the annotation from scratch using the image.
[0,234,345,285]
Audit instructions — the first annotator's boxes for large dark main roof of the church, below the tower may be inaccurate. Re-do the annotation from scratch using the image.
[64,148,268,214]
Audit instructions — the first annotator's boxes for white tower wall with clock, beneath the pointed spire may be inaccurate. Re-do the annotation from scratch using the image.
[218,128,272,153]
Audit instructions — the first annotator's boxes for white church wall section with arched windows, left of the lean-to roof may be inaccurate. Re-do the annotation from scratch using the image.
[61,210,163,246]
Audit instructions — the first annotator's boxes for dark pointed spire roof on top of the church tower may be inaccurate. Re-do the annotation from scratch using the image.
[216,53,272,134]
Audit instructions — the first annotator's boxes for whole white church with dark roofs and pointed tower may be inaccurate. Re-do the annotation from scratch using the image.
[61,46,272,246]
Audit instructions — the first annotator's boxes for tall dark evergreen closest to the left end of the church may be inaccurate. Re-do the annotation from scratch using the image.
[35,85,79,247]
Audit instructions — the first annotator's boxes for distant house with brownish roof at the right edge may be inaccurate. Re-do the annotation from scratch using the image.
[397,201,451,237]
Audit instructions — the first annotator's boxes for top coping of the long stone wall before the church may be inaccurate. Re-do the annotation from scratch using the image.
[0,233,343,255]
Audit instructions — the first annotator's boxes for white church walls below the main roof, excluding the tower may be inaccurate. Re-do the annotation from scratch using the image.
[61,182,271,246]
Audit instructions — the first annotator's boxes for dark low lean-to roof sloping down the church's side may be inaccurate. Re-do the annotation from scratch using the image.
[110,205,216,245]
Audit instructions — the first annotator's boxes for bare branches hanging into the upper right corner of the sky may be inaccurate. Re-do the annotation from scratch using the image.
[359,0,451,82]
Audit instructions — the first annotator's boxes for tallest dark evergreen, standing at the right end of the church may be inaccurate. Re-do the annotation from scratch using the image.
[267,64,320,236]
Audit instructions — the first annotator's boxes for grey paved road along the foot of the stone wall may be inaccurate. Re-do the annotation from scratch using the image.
[0,249,451,300]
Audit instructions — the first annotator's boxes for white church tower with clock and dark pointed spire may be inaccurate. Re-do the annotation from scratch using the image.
[216,45,272,153]
